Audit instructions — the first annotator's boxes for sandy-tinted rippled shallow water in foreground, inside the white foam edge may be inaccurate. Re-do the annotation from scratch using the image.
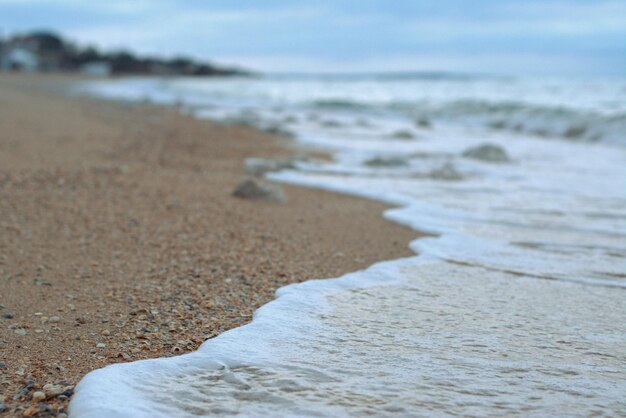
[122,263,626,416]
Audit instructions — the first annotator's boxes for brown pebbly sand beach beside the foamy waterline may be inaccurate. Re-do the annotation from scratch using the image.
[0,74,415,416]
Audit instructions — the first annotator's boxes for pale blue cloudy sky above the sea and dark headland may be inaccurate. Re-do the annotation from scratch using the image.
[0,0,626,77]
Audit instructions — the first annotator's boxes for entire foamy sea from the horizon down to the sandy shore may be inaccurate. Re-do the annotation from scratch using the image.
[70,74,626,417]
